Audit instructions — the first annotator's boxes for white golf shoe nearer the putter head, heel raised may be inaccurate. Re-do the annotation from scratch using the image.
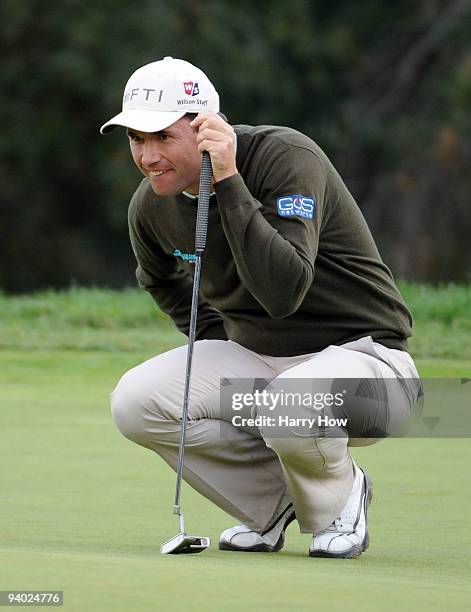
[219,503,296,552]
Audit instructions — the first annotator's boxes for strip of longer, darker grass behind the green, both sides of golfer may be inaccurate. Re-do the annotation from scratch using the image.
[0,283,471,361]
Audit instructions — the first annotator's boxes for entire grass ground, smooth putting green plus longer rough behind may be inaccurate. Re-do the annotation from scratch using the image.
[0,286,471,612]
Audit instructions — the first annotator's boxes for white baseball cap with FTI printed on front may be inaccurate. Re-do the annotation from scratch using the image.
[100,57,219,134]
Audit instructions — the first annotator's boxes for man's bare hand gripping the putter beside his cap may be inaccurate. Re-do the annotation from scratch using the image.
[190,113,238,183]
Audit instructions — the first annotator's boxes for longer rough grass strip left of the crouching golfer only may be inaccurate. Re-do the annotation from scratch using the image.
[0,288,185,354]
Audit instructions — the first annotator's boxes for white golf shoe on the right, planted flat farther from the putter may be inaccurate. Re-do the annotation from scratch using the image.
[309,466,373,559]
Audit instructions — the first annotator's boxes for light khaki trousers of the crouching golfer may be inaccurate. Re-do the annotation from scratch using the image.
[111,336,418,533]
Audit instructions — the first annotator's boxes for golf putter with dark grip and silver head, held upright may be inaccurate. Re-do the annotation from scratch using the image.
[160,151,212,555]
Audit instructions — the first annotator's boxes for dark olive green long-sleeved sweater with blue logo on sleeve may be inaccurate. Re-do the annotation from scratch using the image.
[129,125,412,356]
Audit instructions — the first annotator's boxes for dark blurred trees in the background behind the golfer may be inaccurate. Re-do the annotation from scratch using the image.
[0,0,471,291]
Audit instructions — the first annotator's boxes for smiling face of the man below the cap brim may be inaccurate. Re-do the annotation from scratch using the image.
[127,117,201,196]
